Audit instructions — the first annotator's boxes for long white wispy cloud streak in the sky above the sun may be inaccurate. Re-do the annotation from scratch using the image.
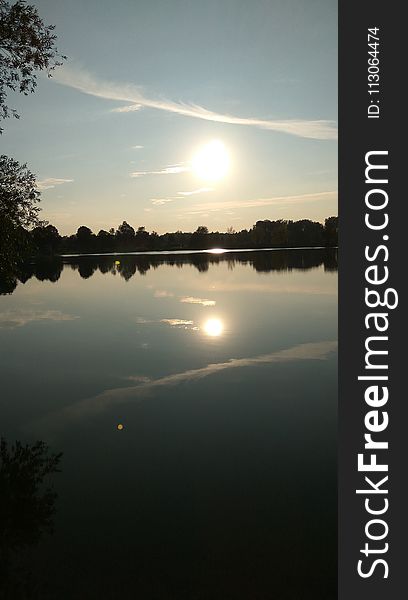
[54,66,337,140]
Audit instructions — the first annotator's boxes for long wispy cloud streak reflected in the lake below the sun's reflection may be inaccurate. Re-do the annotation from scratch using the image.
[27,341,337,429]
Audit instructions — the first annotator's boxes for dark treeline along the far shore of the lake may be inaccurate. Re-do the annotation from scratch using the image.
[25,217,338,255]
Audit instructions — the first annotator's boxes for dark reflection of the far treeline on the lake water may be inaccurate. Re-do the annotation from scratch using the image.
[0,248,337,302]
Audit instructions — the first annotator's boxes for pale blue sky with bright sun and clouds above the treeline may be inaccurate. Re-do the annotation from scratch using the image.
[0,0,337,234]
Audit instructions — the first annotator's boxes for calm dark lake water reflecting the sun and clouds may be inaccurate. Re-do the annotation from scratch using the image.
[0,249,337,600]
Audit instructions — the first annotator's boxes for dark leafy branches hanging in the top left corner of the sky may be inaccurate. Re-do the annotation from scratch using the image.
[0,0,66,133]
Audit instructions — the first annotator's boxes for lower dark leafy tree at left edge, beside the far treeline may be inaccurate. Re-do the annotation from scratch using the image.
[0,155,40,276]
